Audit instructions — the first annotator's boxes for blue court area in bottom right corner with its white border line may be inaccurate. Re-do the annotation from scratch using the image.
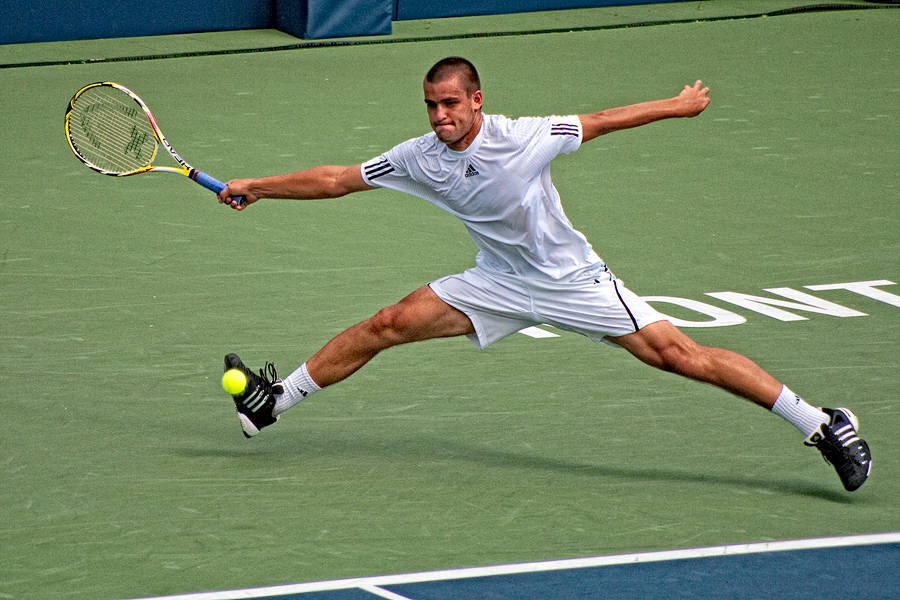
[134,533,900,600]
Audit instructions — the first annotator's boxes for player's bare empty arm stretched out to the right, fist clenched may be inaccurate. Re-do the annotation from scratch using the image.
[578,80,709,142]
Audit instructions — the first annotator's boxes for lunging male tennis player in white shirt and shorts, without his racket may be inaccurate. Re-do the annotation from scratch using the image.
[219,57,872,491]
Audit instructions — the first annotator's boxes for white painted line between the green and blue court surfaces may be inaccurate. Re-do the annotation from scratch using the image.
[126,532,900,600]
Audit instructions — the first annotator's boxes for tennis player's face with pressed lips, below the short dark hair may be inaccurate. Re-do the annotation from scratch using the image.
[425,76,482,151]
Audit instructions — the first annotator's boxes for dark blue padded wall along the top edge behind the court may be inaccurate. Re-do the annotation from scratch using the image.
[0,0,673,44]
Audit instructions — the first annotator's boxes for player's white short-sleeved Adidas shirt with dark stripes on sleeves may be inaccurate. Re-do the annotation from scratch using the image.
[362,115,606,280]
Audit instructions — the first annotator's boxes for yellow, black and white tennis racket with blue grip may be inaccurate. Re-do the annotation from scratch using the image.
[66,81,244,204]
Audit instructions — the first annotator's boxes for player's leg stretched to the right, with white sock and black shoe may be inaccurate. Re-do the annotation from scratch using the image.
[607,321,872,491]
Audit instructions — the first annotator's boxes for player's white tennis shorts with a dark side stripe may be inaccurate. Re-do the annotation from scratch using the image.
[429,267,666,348]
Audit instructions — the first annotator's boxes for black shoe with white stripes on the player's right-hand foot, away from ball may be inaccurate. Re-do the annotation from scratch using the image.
[804,408,872,492]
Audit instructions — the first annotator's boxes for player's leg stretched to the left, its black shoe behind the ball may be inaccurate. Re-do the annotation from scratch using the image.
[225,286,474,437]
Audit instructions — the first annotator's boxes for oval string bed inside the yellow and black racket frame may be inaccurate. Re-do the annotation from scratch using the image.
[69,86,157,173]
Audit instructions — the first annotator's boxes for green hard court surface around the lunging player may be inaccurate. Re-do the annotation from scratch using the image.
[0,3,900,599]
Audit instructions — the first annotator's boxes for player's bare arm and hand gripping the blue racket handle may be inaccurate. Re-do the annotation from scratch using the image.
[219,165,374,210]
